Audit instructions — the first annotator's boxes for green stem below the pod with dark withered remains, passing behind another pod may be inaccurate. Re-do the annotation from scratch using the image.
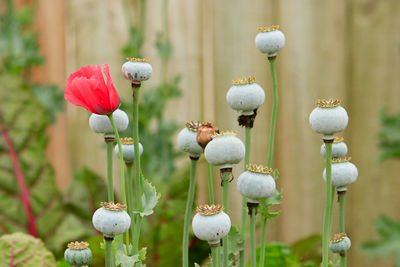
[239,127,251,267]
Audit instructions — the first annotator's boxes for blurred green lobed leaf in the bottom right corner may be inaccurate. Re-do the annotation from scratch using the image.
[361,215,400,266]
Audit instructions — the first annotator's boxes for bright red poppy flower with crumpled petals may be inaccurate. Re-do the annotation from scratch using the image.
[64,64,120,115]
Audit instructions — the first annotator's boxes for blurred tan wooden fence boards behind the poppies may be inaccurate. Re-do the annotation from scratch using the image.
[32,0,400,266]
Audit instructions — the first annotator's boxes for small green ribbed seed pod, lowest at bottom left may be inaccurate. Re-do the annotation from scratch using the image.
[64,241,92,266]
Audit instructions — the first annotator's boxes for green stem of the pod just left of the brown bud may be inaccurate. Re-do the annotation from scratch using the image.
[182,159,197,267]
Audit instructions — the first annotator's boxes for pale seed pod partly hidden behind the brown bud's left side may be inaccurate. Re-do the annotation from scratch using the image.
[178,121,203,159]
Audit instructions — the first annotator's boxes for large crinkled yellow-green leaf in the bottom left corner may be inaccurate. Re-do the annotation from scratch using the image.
[0,233,56,267]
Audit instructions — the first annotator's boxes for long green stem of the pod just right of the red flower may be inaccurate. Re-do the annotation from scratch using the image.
[132,83,143,254]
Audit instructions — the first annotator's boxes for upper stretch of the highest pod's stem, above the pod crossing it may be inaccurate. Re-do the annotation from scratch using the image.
[268,57,278,168]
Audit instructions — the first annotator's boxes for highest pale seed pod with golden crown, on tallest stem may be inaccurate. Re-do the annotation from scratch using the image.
[255,25,285,57]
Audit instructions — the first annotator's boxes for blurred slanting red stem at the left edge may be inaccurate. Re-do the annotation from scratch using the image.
[0,119,37,237]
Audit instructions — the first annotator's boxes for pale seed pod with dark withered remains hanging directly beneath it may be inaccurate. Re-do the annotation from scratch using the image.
[226,77,265,115]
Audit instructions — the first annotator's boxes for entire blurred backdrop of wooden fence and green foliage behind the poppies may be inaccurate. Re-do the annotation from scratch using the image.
[0,0,400,266]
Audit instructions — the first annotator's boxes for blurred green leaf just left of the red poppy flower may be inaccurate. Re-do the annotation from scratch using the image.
[32,84,65,123]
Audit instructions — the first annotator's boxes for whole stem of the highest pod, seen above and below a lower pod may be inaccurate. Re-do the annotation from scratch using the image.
[260,57,278,266]
